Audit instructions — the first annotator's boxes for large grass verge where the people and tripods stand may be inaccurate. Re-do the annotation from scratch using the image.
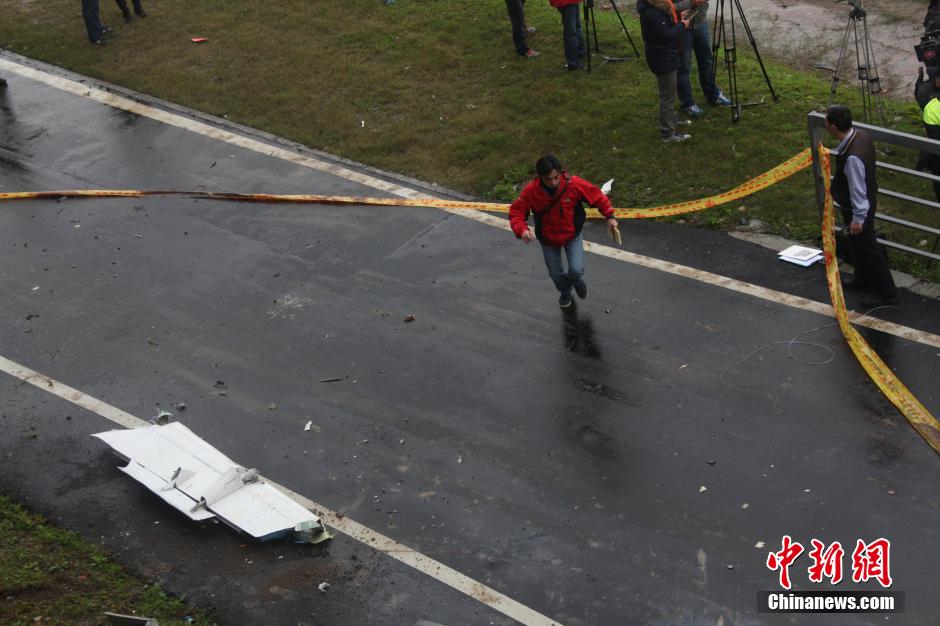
[0,0,940,280]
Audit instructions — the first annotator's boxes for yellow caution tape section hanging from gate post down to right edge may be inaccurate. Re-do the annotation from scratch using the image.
[819,146,940,453]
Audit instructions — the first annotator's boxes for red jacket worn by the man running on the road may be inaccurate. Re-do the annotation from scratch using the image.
[509,173,614,246]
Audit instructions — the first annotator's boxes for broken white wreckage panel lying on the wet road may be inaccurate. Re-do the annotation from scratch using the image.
[92,422,330,543]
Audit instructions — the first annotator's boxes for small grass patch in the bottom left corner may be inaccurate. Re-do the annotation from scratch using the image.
[0,495,213,625]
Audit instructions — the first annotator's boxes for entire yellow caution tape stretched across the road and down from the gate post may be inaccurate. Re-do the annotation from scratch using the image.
[0,146,940,453]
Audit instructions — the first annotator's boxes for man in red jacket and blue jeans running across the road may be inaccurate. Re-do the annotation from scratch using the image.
[509,154,617,309]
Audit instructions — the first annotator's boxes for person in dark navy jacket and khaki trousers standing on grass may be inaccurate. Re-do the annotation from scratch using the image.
[636,0,691,143]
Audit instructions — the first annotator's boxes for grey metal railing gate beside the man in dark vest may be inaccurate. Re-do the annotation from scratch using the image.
[807,111,940,263]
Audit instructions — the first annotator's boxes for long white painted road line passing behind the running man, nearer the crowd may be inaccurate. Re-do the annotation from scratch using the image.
[0,56,940,348]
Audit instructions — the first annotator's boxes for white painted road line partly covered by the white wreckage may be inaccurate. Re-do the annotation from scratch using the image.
[0,356,562,626]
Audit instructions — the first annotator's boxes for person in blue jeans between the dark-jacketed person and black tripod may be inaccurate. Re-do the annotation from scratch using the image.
[675,0,732,117]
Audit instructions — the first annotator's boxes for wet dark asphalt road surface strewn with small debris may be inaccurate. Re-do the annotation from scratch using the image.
[0,59,940,625]
